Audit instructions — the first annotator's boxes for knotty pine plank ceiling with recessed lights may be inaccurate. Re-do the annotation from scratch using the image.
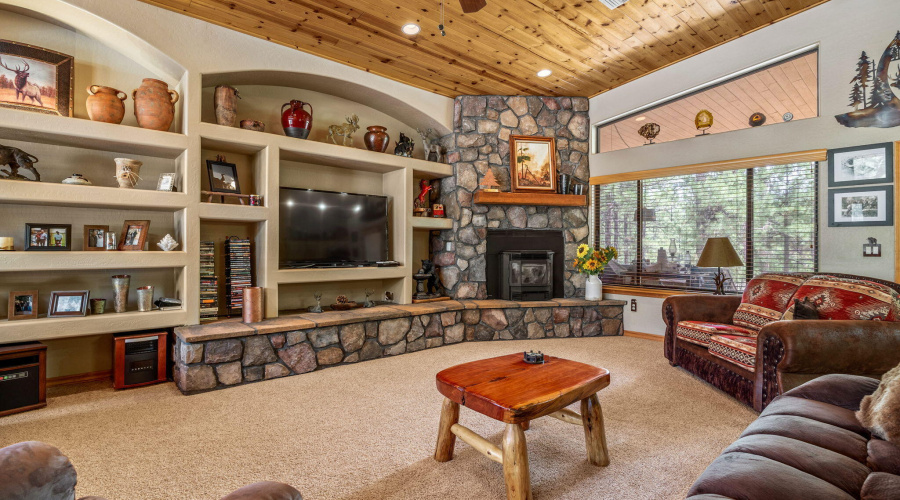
[141,0,828,97]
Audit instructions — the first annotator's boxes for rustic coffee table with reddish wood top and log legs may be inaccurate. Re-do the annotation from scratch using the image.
[434,353,609,500]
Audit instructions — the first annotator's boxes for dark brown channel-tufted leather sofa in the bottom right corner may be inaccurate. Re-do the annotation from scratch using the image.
[688,375,900,500]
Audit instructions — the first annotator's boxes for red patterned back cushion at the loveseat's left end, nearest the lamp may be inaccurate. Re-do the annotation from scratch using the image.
[732,274,806,332]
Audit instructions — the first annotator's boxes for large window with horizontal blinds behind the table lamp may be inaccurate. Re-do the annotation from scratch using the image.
[592,162,819,292]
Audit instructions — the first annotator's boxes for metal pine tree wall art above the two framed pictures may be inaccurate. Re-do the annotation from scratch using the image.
[835,31,900,128]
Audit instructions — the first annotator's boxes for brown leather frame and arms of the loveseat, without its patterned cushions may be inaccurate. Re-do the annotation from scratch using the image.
[662,273,900,411]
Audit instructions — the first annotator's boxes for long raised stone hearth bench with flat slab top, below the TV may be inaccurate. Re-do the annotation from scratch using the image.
[173,299,625,394]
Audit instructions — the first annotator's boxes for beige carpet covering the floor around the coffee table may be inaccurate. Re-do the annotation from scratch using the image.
[0,337,755,500]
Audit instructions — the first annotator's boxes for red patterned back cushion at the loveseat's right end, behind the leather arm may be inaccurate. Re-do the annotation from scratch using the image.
[782,275,900,321]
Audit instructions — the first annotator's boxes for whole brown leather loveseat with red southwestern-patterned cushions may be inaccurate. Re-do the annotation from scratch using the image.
[663,273,900,411]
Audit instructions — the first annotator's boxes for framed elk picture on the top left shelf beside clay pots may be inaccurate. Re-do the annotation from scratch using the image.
[0,40,75,116]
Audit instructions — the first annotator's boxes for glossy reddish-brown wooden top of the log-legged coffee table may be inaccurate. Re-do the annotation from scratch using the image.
[437,352,609,424]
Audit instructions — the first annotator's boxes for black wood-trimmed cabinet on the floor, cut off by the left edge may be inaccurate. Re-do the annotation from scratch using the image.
[0,342,47,417]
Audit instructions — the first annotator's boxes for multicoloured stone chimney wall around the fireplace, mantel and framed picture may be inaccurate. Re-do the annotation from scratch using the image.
[431,96,590,299]
